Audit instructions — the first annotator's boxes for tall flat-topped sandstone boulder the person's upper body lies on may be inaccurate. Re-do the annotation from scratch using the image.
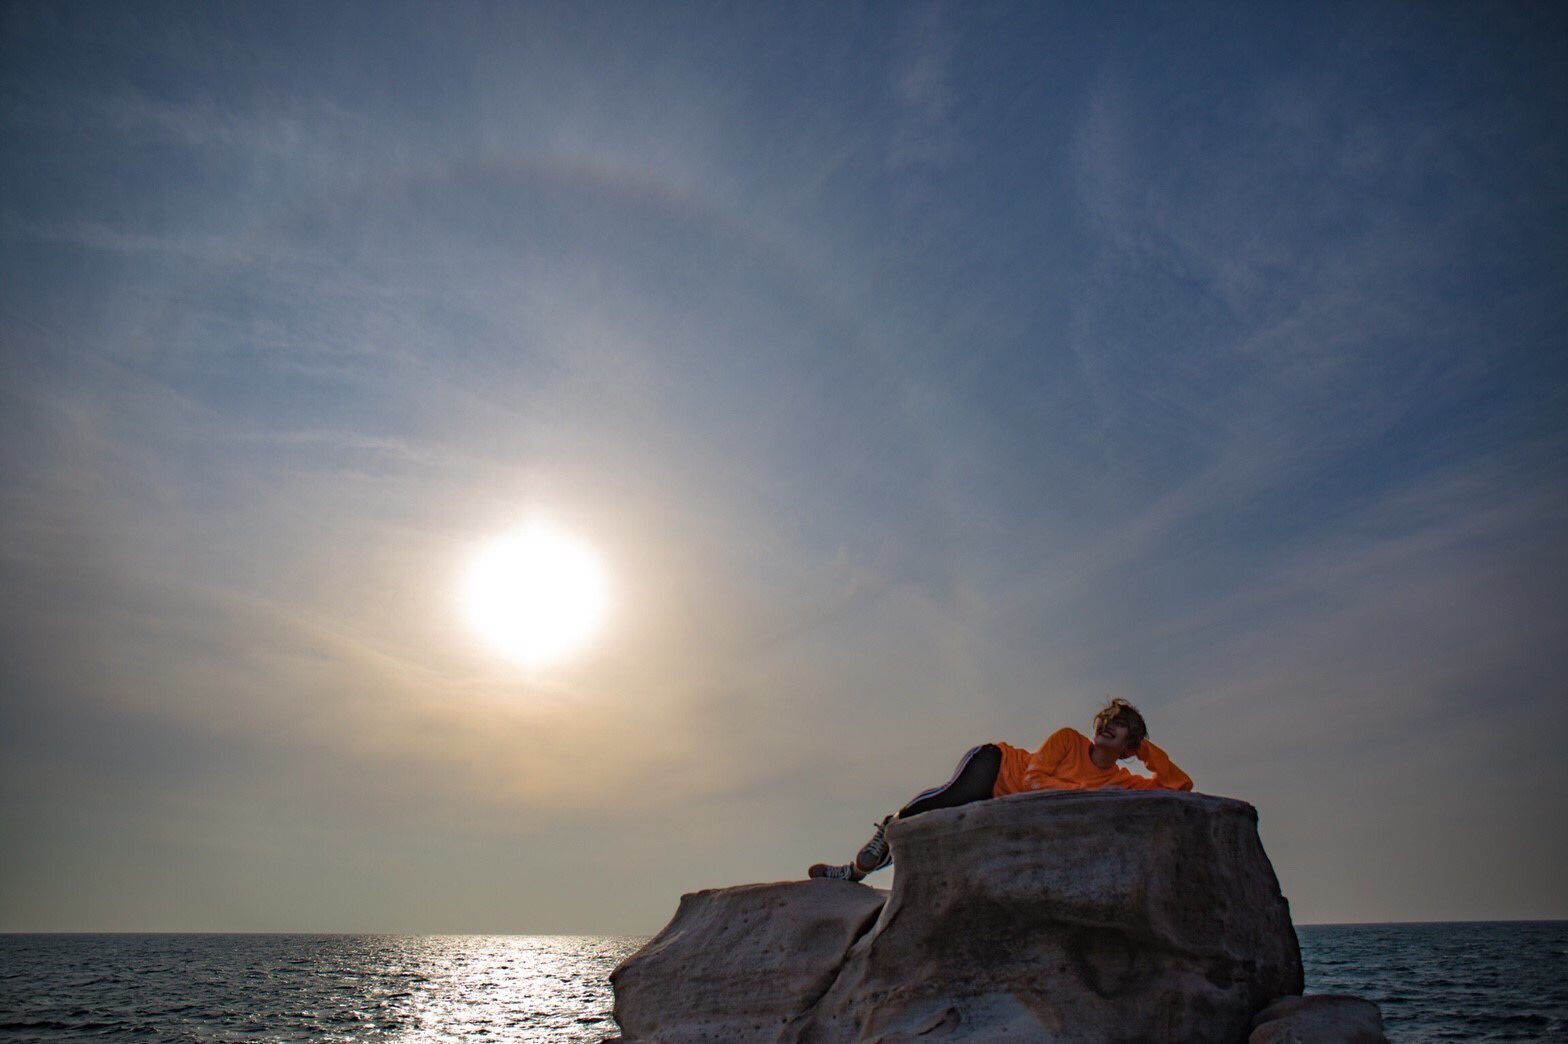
[795,790,1301,1044]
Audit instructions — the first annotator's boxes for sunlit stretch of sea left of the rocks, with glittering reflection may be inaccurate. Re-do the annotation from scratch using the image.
[0,936,643,1042]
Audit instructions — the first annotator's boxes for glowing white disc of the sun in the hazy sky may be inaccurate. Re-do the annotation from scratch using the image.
[463,522,610,666]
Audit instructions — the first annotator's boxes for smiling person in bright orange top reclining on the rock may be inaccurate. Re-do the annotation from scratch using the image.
[806,699,1192,881]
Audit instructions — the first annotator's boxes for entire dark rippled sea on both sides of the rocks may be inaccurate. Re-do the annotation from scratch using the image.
[0,920,1568,1044]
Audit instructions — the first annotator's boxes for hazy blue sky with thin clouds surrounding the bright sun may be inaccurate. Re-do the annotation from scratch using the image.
[0,0,1568,934]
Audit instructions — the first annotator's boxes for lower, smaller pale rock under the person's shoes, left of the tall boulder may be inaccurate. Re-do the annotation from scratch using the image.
[610,881,887,1044]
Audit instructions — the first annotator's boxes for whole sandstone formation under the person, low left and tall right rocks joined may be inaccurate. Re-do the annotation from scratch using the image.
[612,790,1361,1044]
